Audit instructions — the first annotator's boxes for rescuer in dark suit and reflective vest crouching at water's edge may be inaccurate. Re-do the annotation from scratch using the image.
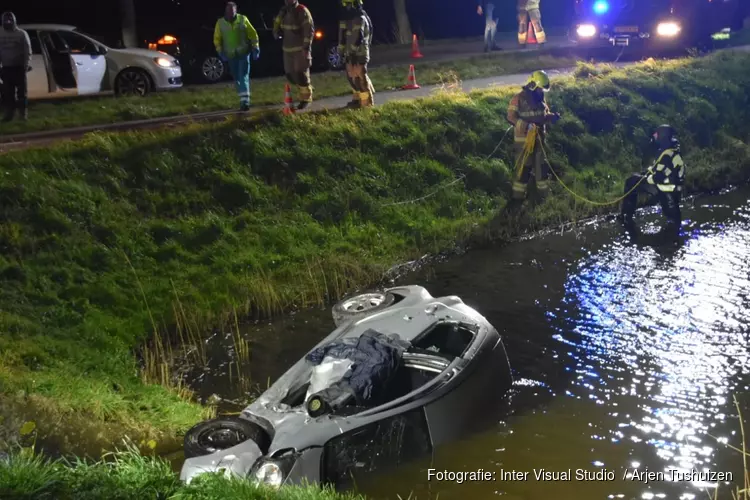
[620,125,685,228]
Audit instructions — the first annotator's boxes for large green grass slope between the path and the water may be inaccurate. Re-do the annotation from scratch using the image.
[0,48,750,453]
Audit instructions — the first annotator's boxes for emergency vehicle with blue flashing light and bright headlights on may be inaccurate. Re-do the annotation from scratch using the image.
[570,0,743,50]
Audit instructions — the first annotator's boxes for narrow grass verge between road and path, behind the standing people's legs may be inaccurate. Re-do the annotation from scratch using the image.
[0,49,575,135]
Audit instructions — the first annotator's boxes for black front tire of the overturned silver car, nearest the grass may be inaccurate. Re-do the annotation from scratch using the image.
[184,417,271,459]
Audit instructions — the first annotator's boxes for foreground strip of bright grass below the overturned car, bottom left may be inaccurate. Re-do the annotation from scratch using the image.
[0,449,363,500]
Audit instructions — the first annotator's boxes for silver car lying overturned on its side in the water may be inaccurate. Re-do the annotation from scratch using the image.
[180,286,512,489]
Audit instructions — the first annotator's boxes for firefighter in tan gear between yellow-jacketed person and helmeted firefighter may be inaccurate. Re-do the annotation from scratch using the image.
[273,0,315,109]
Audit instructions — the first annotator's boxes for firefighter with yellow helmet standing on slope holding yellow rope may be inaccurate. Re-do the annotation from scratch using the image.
[507,71,560,200]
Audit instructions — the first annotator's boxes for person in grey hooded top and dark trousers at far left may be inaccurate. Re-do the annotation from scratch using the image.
[0,12,31,122]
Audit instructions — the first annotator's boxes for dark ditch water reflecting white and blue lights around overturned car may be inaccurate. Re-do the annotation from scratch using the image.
[184,189,750,500]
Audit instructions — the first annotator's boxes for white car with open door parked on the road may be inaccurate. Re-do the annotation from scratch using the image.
[19,24,182,99]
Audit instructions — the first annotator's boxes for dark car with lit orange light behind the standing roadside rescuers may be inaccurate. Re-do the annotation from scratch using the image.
[149,13,343,83]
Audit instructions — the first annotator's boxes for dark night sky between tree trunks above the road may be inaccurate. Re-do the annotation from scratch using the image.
[3,0,573,45]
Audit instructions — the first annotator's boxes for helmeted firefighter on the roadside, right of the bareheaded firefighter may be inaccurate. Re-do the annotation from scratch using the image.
[338,0,375,108]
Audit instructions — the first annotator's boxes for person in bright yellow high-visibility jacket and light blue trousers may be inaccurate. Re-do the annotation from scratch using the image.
[214,2,260,111]
